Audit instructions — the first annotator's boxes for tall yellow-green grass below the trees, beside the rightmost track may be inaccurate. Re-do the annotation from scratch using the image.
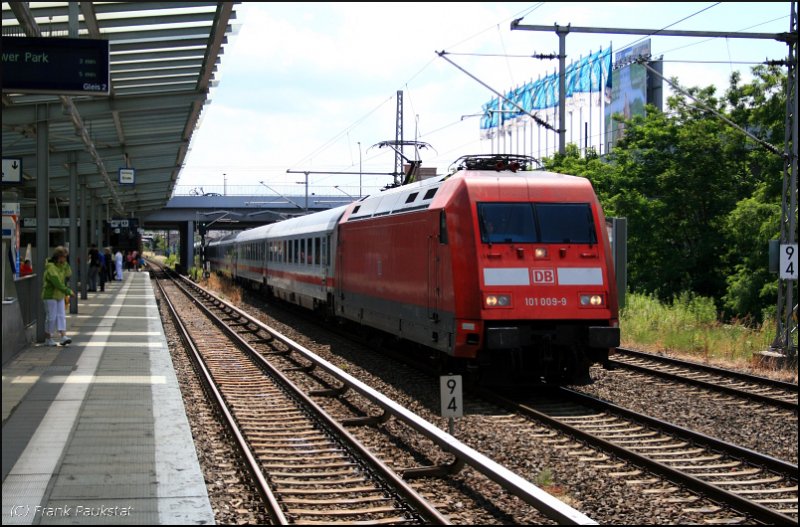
[620,293,797,382]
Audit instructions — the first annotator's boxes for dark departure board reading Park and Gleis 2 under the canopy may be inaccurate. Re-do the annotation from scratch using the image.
[2,37,111,95]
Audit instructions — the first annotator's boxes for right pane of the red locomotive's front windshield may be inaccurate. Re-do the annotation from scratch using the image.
[535,203,597,244]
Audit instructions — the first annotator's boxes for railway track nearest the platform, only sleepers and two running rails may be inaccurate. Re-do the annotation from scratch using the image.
[152,270,449,525]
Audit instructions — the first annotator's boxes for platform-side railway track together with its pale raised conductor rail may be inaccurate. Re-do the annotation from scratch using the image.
[153,270,595,524]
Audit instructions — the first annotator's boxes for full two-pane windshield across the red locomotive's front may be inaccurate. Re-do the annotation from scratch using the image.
[478,203,597,244]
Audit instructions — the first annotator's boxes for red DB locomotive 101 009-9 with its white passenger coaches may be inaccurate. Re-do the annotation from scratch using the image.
[205,154,620,384]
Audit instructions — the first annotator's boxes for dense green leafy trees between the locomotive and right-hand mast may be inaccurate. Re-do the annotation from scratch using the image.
[544,66,786,319]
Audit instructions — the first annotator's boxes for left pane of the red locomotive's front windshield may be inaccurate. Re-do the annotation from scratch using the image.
[478,203,539,243]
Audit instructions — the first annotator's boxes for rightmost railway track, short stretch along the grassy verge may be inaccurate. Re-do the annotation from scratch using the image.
[610,348,798,412]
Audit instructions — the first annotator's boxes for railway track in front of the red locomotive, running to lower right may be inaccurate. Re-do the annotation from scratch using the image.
[480,388,798,524]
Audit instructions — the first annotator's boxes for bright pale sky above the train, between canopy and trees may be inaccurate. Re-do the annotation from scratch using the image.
[176,2,790,200]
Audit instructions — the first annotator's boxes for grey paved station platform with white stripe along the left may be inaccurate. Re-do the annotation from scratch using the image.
[2,272,214,525]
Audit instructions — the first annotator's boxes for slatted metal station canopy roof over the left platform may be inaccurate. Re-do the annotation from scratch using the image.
[2,2,239,216]
